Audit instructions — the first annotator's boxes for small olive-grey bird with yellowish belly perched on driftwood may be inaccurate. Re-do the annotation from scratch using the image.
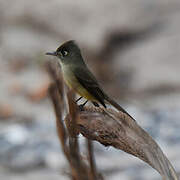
[46,40,132,118]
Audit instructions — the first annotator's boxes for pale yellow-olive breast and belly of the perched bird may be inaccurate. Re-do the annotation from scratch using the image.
[62,66,96,101]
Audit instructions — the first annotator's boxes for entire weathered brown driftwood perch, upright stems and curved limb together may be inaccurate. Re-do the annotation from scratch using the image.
[48,61,178,180]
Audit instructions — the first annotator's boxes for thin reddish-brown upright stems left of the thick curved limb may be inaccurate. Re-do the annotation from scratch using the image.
[46,63,103,180]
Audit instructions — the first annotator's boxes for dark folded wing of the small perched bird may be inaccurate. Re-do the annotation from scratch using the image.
[74,67,106,107]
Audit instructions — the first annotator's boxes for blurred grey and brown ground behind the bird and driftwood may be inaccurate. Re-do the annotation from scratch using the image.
[0,0,180,180]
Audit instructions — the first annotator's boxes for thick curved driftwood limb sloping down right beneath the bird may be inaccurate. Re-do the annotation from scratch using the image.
[77,107,178,180]
